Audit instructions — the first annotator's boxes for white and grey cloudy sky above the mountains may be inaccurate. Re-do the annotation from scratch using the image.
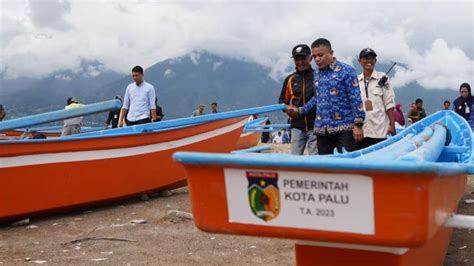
[0,0,474,90]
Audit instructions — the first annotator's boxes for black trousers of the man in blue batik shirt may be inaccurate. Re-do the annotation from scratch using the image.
[317,131,356,154]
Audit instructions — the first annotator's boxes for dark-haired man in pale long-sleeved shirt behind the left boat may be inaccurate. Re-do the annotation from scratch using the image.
[118,66,156,127]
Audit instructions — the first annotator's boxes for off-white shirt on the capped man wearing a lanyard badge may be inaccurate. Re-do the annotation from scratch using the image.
[358,70,395,139]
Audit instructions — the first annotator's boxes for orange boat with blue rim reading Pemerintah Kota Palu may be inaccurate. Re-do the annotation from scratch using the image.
[174,111,474,265]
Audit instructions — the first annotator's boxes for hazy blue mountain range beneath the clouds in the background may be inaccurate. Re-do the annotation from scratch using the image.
[0,51,458,124]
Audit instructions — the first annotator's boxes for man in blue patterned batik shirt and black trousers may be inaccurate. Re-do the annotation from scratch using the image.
[287,38,365,154]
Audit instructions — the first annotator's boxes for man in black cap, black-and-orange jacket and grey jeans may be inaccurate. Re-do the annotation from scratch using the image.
[278,44,318,155]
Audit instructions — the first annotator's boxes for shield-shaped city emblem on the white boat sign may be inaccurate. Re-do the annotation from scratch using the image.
[246,171,281,222]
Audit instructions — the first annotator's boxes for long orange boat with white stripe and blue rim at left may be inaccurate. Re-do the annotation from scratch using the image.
[0,105,283,220]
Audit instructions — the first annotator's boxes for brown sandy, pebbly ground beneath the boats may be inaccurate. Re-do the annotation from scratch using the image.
[0,145,474,265]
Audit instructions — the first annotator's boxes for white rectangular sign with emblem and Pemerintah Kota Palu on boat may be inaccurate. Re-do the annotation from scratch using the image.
[224,169,375,235]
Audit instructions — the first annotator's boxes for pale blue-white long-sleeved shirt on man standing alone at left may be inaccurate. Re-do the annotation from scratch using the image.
[122,81,156,122]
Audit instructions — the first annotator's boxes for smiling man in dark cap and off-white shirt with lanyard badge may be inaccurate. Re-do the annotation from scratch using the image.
[357,48,396,149]
